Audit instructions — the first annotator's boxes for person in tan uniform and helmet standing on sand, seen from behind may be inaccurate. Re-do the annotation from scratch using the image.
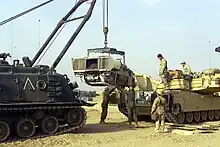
[151,90,167,133]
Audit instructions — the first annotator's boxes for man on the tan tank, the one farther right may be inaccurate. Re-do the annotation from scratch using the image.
[181,61,192,89]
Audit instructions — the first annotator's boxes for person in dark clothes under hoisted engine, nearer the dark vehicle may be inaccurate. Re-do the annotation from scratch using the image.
[100,86,116,123]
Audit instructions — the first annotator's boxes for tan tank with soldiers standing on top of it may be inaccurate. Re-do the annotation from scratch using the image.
[121,69,220,123]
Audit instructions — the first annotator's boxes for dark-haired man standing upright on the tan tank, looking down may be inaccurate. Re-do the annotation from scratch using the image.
[157,54,169,89]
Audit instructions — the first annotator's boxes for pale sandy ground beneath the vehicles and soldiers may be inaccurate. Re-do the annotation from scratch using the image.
[0,96,220,147]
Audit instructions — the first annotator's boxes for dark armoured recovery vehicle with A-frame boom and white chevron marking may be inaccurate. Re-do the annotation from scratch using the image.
[0,0,96,142]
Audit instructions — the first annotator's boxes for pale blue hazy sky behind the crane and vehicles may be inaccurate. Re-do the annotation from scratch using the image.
[0,0,220,89]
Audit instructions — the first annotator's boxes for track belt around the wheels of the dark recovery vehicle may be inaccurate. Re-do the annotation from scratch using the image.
[0,103,87,143]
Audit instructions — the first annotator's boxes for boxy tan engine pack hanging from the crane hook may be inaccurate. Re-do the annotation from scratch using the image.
[72,48,133,86]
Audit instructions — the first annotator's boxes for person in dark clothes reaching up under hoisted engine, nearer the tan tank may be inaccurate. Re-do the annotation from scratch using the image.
[118,85,138,127]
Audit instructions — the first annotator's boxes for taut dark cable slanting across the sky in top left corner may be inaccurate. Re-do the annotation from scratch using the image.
[0,0,54,26]
